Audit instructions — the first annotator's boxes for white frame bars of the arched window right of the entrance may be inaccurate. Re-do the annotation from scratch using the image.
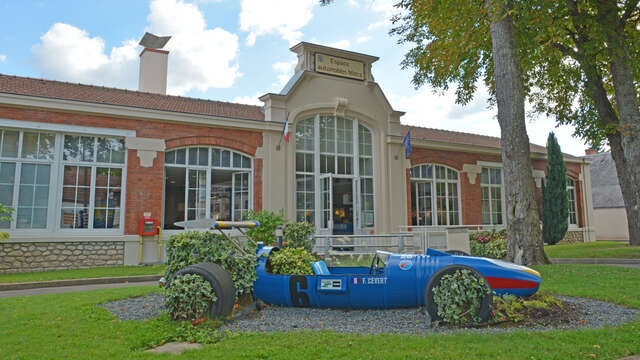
[410,163,462,227]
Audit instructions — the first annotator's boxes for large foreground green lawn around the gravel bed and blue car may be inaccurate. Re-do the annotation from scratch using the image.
[0,265,640,360]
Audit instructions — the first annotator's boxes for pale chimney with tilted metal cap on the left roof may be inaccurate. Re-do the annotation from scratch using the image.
[138,33,171,95]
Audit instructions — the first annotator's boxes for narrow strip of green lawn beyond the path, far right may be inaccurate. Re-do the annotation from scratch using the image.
[544,241,640,259]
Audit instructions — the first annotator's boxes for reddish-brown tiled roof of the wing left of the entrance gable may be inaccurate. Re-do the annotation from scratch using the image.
[0,74,264,121]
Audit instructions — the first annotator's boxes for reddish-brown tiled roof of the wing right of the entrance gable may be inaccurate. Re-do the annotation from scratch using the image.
[403,125,552,158]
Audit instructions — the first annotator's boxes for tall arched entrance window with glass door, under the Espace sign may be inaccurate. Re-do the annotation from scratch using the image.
[296,115,375,234]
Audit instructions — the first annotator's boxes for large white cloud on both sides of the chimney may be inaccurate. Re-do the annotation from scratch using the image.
[32,0,241,95]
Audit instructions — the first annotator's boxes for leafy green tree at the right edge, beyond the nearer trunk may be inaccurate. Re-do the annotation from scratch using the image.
[516,0,640,245]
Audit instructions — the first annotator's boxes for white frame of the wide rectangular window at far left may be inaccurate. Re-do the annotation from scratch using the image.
[0,119,131,236]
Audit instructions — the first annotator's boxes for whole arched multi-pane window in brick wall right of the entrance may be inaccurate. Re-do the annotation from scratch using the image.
[411,164,460,226]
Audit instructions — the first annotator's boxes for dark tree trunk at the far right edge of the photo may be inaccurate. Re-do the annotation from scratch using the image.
[598,2,640,245]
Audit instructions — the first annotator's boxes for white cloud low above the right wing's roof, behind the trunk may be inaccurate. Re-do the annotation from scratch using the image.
[387,86,585,156]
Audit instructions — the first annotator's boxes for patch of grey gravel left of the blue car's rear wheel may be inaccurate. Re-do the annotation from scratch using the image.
[98,294,164,320]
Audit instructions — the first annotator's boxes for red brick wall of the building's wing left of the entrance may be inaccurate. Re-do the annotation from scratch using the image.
[0,106,262,234]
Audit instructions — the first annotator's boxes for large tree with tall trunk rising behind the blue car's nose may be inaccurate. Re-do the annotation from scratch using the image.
[392,0,549,265]
